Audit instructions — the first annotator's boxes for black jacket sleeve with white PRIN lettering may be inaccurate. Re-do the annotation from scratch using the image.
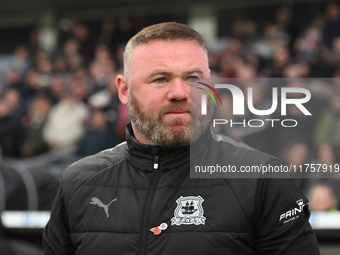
[252,173,320,255]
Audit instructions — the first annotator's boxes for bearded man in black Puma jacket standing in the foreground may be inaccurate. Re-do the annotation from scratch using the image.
[43,23,319,255]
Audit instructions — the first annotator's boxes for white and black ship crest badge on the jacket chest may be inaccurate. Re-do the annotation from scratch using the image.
[171,196,206,226]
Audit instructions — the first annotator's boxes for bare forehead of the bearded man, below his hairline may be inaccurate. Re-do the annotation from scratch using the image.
[131,39,208,69]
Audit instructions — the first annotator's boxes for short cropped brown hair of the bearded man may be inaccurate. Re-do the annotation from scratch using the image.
[123,22,207,79]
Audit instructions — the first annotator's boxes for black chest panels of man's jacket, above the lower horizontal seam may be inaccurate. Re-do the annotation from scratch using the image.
[69,165,251,233]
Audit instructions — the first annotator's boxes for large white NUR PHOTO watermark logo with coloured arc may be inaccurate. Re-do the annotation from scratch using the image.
[191,78,312,128]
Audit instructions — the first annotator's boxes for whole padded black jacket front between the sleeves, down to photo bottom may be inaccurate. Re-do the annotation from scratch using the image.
[69,165,252,254]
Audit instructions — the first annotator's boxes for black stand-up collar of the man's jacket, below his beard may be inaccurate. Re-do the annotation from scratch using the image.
[126,123,211,172]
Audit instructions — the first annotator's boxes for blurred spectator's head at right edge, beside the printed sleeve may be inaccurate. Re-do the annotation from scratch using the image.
[308,185,338,212]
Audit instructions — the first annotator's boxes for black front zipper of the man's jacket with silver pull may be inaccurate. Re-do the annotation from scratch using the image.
[139,155,159,255]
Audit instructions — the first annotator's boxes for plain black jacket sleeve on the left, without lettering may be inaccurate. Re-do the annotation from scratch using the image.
[43,183,75,255]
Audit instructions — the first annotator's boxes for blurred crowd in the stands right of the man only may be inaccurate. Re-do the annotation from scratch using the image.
[209,3,340,211]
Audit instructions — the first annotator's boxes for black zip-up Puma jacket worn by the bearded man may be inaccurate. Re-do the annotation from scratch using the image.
[43,122,319,255]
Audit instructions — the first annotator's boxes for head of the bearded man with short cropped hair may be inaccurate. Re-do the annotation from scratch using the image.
[117,22,210,147]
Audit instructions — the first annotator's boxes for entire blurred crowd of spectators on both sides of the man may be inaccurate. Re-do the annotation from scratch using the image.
[0,3,340,214]
